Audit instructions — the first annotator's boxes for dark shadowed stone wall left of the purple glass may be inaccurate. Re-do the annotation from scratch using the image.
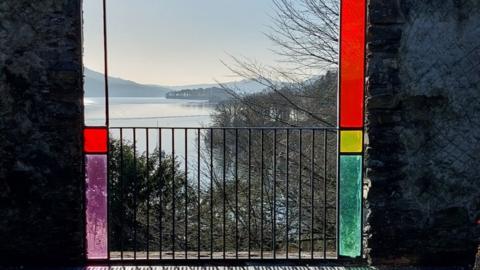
[0,0,84,264]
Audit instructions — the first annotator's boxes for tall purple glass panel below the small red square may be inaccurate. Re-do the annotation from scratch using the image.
[85,155,108,259]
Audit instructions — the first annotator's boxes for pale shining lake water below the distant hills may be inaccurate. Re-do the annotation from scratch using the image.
[84,98,214,177]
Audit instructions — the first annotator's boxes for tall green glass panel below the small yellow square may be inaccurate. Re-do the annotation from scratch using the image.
[339,155,362,257]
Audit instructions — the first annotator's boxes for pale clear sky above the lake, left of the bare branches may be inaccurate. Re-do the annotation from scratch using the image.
[83,0,278,86]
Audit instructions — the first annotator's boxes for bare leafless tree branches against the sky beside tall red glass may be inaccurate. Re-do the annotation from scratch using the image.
[221,0,340,126]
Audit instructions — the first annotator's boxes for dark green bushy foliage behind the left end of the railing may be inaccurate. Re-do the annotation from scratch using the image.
[109,139,194,250]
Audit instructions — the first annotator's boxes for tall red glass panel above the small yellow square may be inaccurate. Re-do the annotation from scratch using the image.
[339,0,366,128]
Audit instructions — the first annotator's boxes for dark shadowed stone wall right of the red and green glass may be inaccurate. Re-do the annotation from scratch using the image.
[366,0,480,265]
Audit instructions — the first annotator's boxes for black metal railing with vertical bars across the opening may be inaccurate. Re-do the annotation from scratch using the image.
[109,127,337,261]
